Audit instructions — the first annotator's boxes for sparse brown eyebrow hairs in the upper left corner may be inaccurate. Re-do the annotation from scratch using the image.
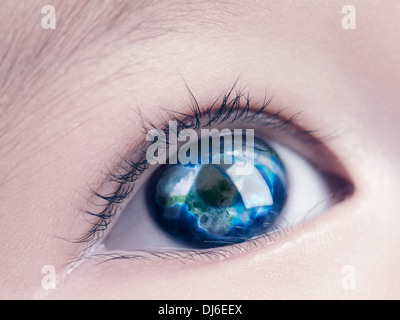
[0,0,178,182]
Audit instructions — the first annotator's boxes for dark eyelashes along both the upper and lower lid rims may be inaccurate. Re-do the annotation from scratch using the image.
[72,84,319,261]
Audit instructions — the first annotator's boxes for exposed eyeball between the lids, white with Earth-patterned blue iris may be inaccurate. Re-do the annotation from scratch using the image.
[103,130,354,254]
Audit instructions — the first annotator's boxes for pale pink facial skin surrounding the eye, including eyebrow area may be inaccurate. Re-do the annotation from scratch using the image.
[0,0,400,299]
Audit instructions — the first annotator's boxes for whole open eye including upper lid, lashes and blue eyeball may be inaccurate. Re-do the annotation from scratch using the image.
[76,91,352,259]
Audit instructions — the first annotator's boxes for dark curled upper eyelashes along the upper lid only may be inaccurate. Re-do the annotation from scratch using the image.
[71,86,321,259]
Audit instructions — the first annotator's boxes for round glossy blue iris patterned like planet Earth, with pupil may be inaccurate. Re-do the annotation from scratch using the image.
[147,134,286,248]
